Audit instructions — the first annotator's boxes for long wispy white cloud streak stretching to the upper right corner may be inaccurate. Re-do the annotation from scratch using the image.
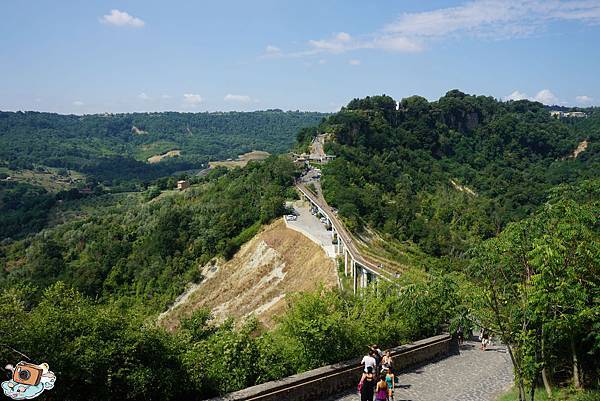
[270,0,600,57]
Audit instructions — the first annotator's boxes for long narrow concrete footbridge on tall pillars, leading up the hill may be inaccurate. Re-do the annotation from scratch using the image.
[296,182,395,294]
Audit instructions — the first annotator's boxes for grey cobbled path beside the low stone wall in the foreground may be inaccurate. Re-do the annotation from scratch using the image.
[327,342,513,401]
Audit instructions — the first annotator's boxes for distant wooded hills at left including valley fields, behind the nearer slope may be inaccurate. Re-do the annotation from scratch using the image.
[0,110,324,241]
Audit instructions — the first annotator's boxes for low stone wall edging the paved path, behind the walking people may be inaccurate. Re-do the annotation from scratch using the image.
[211,334,451,401]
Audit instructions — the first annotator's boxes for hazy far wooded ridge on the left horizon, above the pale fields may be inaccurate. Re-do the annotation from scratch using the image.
[0,110,324,185]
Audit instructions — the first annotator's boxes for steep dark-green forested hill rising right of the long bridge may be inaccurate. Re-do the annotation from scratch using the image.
[314,90,600,256]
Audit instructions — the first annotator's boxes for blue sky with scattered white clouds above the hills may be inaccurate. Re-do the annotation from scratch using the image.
[0,0,600,114]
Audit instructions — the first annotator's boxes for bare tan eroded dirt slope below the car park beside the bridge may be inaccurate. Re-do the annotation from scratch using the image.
[160,219,337,329]
